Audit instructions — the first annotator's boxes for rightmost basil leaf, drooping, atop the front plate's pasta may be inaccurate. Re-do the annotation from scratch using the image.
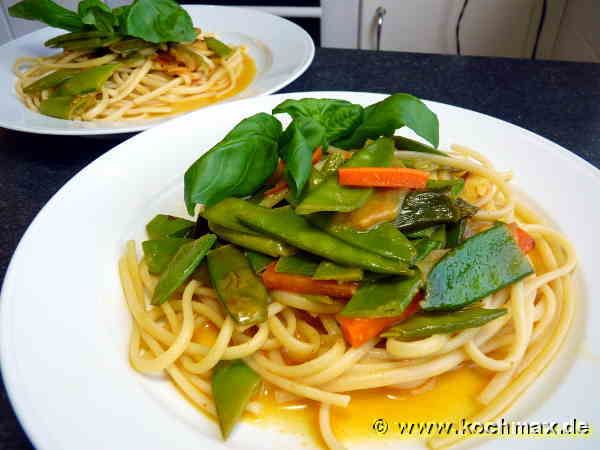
[334,94,439,148]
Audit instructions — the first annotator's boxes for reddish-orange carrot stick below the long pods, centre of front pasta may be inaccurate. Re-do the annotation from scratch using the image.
[262,263,358,298]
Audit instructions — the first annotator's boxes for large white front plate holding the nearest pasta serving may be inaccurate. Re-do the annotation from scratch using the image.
[0,92,600,450]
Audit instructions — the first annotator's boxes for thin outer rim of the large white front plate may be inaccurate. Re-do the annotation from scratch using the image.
[0,91,600,448]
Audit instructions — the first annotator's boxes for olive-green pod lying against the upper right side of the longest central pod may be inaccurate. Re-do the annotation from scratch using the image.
[307,214,416,264]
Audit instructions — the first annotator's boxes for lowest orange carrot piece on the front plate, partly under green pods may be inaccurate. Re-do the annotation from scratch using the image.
[337,292,423,347]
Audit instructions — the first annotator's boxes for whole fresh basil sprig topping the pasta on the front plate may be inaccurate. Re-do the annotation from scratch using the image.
[183,93,439,214]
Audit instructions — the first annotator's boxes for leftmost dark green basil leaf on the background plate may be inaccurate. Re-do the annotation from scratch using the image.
[8,0,85,31]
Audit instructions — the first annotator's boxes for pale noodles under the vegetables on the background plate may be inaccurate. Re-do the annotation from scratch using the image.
[13,33,253,121]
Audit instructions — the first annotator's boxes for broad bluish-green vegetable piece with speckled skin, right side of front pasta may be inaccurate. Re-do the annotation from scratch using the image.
[421,223,533,311]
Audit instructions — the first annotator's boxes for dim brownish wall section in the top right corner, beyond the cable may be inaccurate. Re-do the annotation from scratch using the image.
[550,0,600,63]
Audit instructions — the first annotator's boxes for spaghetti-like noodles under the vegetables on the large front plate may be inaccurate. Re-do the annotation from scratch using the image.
[118,142,576,450]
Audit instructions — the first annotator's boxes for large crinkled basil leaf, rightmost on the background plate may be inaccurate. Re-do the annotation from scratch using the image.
[125,0,196,44]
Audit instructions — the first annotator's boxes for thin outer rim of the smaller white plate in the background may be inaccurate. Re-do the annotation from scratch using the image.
[0,4,316,136]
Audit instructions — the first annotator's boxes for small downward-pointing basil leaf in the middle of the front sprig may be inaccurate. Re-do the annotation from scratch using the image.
[279,117,327,198]
